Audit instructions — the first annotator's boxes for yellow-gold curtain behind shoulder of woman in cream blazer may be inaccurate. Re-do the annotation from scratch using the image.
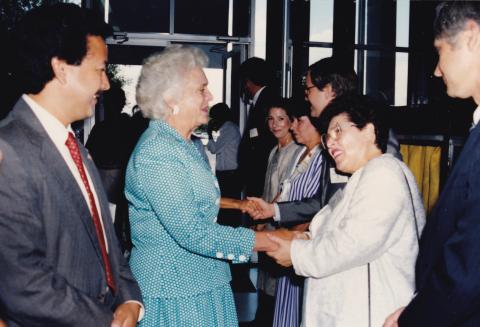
[400,144,441,213]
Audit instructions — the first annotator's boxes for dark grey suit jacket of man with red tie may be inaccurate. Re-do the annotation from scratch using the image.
[0,99,141,327]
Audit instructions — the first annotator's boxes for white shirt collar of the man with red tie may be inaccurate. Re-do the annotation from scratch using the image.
[22,94,73,147]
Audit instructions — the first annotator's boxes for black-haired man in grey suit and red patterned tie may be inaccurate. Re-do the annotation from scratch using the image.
[0,4,143,327]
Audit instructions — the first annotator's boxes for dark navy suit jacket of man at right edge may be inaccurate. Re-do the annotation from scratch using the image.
[399,126,480,326]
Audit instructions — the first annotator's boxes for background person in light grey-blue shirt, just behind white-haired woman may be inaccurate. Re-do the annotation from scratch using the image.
[207,103,241,227]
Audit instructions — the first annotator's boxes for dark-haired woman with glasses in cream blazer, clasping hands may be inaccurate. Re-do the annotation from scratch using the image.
[268,95,425,327]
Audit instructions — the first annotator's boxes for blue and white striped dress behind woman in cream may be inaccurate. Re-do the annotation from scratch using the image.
[273,146,324,327]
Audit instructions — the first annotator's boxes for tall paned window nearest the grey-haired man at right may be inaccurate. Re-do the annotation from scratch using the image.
[355,0,410,106]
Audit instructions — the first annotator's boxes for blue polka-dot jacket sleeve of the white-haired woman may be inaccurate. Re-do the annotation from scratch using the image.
[135,150,255,262]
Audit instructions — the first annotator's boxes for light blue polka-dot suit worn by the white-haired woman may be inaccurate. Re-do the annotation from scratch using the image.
[125,120,255,327]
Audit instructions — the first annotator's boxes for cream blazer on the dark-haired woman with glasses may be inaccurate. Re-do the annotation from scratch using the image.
[291,154,425,327]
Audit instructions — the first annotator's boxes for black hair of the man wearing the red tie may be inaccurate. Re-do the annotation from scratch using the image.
[15,3,111,94]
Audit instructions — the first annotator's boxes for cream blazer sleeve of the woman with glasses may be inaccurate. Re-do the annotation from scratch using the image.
[291,161,408,278]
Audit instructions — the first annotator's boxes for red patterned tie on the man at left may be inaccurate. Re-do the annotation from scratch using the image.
[65,133,115,292]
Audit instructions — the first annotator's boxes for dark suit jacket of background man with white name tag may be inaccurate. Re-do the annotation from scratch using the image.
[238,86,279,197]
